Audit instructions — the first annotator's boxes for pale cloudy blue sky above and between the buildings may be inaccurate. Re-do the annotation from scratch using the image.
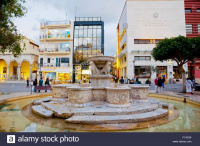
[14,0,125,56]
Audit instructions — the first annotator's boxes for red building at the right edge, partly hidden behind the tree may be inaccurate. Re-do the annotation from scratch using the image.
[185,0,200,82]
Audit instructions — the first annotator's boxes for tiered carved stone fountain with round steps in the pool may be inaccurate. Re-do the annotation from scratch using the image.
[32,56,168,124]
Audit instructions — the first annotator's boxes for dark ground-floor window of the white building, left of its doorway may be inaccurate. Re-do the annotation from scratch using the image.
[135,66,151,78]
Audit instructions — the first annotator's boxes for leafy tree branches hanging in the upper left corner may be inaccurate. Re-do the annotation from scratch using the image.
[0,0,26,57]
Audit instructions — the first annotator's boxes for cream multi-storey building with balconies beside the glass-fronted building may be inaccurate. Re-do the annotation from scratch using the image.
[39,21,74,83]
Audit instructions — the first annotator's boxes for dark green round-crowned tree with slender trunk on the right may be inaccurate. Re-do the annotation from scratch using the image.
[152,36,200,92]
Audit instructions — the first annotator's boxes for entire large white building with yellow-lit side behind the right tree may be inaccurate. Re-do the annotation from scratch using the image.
[117,0,188,83]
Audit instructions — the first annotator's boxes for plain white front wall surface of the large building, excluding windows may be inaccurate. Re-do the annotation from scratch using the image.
[123,0,187,81]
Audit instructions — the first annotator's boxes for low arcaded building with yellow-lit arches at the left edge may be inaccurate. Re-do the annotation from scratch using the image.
[0,37,39,80]
